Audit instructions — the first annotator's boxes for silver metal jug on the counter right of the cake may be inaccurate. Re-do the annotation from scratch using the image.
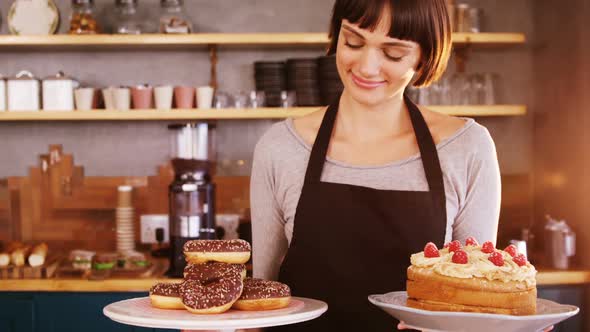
[545,215,576,270]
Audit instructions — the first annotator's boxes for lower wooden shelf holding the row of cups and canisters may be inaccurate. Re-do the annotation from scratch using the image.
[0,105,526,121]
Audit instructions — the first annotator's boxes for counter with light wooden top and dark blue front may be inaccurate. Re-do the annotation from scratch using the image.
[0,269,590,332]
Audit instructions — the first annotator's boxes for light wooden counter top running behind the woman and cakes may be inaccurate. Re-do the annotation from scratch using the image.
[0,270,590,292]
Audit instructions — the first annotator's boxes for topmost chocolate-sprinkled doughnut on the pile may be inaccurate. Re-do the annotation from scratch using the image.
[183,240,251,264]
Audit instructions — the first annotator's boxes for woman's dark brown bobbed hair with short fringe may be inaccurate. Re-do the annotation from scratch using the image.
[328,0,452,87]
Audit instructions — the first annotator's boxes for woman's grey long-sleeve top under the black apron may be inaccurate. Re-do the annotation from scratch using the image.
[250,119,501,280]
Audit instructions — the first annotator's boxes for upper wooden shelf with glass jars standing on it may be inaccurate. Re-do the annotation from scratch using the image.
[0,33,525,48]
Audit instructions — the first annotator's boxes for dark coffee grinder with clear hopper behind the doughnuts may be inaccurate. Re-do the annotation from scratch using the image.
[166,122,216,278]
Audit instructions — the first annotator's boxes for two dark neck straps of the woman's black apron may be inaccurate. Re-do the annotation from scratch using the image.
[305,95,445,197]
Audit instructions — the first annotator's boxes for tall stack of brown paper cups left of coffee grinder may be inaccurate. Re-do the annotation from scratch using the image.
[116,186,135,254]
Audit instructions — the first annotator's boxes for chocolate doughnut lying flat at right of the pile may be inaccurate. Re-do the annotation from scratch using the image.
[233,278,291,310]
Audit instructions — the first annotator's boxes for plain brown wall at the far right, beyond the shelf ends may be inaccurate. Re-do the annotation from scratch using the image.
[534,0,590,267]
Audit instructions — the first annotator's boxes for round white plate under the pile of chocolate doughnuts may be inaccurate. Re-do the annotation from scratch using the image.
[103,297,328,330]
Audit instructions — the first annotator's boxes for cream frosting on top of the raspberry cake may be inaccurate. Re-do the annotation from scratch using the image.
[410,246,537,286]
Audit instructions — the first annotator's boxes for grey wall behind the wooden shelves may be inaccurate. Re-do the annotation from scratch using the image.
[0,0,535,177]
